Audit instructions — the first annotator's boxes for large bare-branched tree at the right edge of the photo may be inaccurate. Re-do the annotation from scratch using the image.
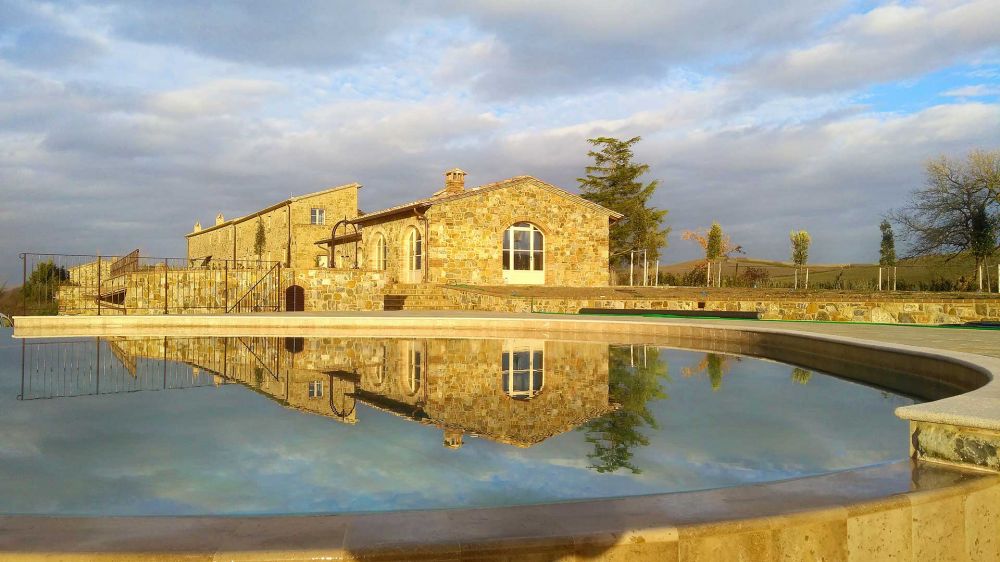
[890,151,1000,270]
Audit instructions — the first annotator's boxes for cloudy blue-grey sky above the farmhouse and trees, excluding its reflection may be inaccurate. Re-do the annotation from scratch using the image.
[0,0,1000,280]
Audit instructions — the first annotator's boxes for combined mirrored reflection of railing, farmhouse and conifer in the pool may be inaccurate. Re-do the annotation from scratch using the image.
[20,337,636,448]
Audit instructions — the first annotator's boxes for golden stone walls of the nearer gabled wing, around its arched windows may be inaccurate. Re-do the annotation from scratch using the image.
[357,176,618,286]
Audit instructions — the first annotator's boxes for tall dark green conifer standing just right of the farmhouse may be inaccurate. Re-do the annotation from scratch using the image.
[577,137,670,265]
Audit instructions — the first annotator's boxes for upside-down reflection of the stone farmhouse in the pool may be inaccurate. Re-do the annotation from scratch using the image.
[107,338,612,448]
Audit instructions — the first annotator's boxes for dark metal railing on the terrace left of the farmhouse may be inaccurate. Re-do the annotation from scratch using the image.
[17,251,284,316]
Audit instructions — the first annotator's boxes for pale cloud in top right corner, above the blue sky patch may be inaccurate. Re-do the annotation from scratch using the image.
[741,0,1000,93]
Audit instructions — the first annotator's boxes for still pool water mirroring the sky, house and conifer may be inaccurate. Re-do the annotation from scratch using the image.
[0,330,913,515]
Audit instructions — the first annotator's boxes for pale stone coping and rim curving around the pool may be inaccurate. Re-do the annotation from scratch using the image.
[7,313,1000,560]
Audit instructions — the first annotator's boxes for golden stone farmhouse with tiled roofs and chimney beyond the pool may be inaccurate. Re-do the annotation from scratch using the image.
[186,168,622,286]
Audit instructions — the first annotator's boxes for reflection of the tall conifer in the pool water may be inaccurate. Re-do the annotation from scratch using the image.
[581,346,667,474]
